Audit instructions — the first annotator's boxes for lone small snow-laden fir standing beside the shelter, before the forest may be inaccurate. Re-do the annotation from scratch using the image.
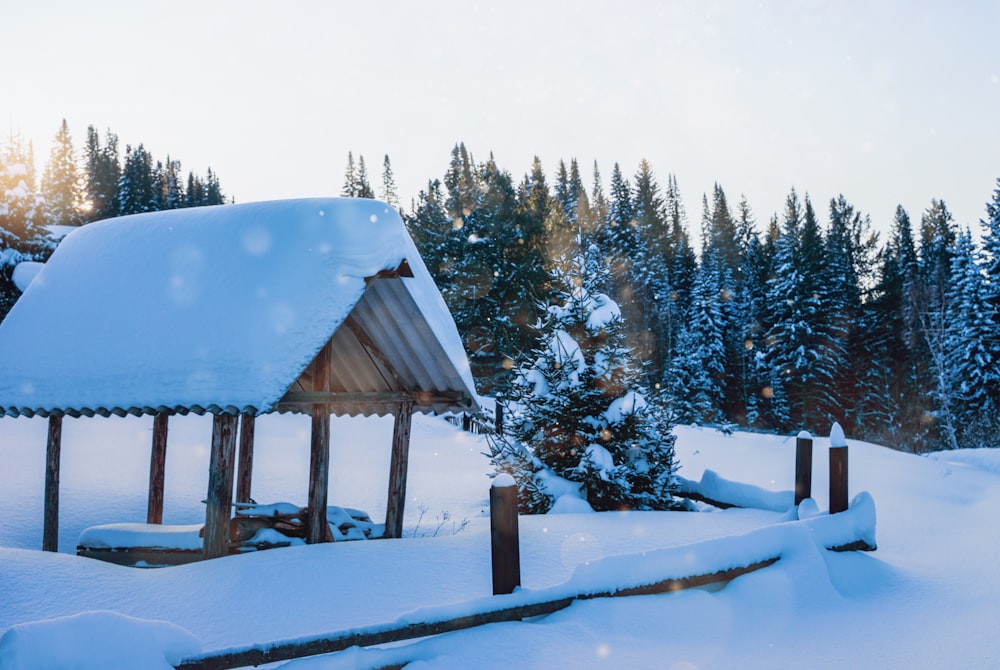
[491,246,677,512]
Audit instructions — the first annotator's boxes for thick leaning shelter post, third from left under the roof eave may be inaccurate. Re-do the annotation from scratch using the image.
[202,414,236,559]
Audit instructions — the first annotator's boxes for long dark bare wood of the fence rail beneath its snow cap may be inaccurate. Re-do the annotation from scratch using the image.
[176,556,779,670]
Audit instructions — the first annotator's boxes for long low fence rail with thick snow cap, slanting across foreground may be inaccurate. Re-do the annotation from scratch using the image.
[175,487,875,670]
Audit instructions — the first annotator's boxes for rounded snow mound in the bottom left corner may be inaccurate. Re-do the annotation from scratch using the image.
[0,611,201,670]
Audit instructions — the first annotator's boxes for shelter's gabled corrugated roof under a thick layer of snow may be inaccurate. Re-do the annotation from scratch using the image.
[0,198,476,416]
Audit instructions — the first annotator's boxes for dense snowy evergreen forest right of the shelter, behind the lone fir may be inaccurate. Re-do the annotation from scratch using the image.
[384,145,1000,452]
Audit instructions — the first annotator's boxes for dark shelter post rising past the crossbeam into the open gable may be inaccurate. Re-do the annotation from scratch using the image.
[306,342,332,544]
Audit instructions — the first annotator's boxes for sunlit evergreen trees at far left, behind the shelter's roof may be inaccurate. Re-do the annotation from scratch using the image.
[0,120,226,320]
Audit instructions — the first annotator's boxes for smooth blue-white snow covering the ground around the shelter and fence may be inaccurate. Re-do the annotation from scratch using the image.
[0,416,1000,670]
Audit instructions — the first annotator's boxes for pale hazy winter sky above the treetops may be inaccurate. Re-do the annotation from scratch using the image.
[7,0,1000,236]
